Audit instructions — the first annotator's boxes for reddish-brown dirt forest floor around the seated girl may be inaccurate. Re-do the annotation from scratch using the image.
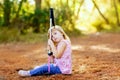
[0,33,120,80]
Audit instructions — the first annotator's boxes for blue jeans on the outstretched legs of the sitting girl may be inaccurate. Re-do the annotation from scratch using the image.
[30,64,61,76]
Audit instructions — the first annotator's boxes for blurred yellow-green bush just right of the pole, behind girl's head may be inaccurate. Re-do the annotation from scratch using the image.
[55,3,81,36]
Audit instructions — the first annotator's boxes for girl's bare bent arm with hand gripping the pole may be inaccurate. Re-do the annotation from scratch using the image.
[48,40,67,59]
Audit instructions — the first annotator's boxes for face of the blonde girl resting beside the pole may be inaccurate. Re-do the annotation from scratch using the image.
[52,30,63,43]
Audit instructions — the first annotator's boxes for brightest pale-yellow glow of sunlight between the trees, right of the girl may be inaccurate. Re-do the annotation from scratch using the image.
[75,0,97,34]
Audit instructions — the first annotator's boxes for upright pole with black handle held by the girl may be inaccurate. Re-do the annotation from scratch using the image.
[48,8,55,73]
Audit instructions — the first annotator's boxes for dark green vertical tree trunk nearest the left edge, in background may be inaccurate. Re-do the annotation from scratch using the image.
[3,0,11,26]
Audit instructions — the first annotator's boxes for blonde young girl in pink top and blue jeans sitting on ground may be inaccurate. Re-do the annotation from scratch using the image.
[18,26,72,76]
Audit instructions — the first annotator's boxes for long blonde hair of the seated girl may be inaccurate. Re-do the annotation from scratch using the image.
[48,25,71,42]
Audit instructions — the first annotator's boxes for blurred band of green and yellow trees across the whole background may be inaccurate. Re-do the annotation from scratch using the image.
[0,0,120,33]
